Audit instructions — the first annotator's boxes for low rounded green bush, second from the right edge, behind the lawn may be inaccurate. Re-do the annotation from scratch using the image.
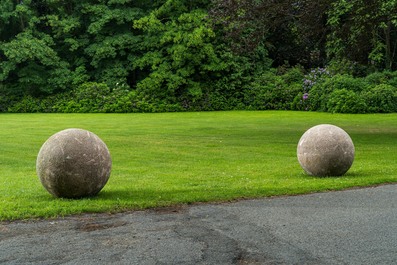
[327,89,367,113]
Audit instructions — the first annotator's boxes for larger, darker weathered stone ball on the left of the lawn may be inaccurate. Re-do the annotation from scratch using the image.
[36,129,112,198]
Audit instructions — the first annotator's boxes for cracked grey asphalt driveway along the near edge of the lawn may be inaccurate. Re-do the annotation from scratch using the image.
[0,185,397,265]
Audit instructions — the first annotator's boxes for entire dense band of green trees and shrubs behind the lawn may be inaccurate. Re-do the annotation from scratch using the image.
[0,0,397,113]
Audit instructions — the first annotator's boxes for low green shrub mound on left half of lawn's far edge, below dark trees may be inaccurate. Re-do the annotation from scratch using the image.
[6,82,183,113]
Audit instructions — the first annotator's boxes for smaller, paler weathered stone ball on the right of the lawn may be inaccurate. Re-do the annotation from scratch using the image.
[297,124,355,177]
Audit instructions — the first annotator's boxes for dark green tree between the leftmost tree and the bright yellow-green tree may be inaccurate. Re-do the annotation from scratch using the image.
[79,1,145,86]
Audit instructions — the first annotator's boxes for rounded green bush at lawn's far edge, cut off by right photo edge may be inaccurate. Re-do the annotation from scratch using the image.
[363,84,397,113]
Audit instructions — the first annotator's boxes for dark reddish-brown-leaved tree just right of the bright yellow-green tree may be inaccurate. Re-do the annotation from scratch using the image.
[210,0,332,67]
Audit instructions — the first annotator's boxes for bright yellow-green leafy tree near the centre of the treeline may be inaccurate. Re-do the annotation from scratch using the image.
[134,0,226,107]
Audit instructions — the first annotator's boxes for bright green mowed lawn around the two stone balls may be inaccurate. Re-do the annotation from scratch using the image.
[0,111,397,221]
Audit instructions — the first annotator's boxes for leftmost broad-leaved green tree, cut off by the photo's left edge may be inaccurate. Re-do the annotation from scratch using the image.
[0,1,72,94]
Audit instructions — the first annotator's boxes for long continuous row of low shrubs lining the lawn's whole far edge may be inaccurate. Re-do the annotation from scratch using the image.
[0,67,397,113]
